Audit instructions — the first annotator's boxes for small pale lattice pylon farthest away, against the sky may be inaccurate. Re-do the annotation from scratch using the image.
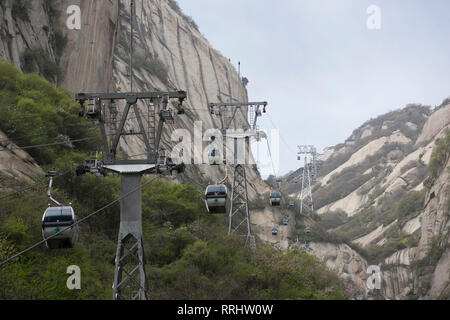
[297,145,317,214]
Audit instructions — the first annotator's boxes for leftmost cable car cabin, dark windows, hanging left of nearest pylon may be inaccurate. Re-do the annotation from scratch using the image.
[42,206,78,249]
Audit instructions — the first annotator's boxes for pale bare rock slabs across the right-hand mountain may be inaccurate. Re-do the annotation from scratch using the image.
[318,103,450,299]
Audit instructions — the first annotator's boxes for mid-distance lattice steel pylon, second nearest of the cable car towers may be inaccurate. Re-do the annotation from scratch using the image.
[208,102,267,247]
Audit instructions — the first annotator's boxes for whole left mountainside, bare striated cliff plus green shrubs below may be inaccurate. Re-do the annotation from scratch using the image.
[0,0,346,299]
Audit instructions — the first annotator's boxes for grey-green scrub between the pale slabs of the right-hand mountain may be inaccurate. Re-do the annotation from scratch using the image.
[316,126,450,263]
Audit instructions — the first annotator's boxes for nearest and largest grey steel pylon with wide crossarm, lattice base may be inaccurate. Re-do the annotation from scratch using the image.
[75,0,187,300]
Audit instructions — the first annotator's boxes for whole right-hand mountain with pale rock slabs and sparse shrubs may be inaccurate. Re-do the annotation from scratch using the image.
[284,99,450,299]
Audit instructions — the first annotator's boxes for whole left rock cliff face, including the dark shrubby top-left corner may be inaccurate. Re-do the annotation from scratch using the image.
[0,0,267,199]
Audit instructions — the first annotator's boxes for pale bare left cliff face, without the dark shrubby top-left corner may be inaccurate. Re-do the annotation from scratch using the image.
[62,0,265,198]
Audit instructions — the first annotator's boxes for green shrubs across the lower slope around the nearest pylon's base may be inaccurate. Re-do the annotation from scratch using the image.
[0,176,345,299]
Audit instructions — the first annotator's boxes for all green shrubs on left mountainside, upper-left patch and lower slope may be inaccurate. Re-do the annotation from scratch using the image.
[0,62,347,300]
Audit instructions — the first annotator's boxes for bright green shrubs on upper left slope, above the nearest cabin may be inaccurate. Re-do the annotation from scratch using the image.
[0,60,98,166]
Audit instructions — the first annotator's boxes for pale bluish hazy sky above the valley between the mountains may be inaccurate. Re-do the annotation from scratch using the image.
[178,0,450,174]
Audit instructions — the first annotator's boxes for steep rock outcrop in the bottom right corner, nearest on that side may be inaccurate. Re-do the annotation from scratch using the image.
[382,157,450,299]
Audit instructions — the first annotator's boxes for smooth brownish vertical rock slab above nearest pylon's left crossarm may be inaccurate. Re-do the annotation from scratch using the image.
[55,0,119,92]
